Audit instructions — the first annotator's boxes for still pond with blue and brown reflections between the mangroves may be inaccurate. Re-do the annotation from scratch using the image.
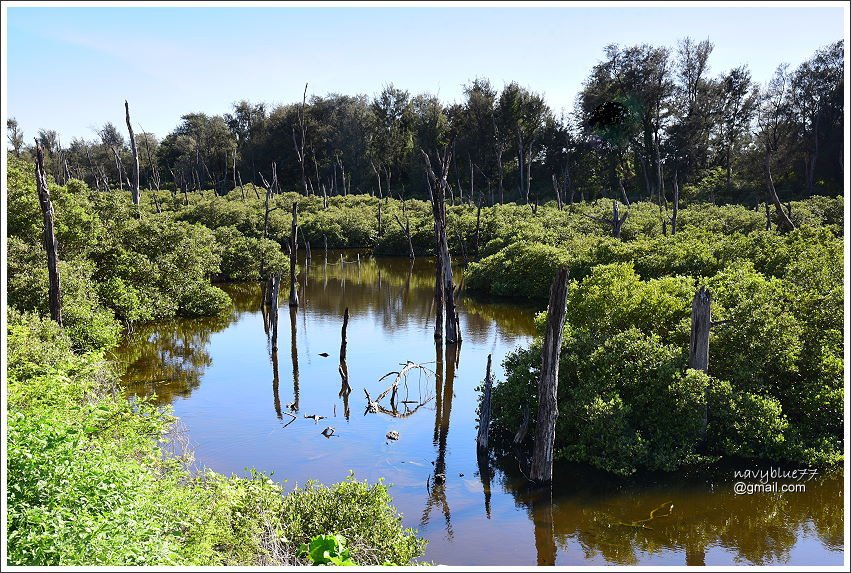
[113,252,844,565]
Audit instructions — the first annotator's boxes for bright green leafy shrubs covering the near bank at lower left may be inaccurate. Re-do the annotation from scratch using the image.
[6,310,424,566]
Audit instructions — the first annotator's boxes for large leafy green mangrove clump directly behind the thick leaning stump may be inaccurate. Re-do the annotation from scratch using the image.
[492,258,843,474]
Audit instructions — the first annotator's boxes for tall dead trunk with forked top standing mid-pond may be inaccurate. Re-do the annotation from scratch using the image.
[420,143,461,344]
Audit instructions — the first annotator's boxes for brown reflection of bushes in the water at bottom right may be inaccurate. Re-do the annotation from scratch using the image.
[498,455,843,565]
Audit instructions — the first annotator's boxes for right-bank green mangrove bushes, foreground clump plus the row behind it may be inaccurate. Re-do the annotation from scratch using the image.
[486,207,843,474]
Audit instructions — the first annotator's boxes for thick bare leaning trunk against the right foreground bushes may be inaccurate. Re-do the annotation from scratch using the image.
[529,268,567,482]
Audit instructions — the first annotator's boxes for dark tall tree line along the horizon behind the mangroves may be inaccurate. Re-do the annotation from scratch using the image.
[7,38,844,205]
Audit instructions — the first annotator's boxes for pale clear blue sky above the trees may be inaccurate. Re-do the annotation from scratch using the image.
[4,5,844,143]
